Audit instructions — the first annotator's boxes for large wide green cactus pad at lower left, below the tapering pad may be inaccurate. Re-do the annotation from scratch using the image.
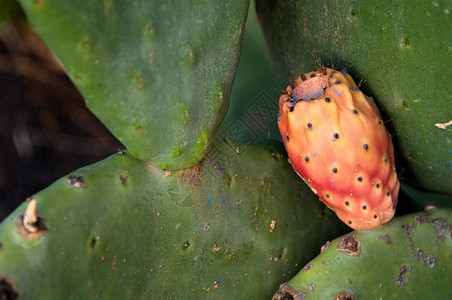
[0,140,347,299]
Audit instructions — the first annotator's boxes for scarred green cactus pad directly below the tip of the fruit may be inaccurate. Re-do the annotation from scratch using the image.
[273,208,452,300]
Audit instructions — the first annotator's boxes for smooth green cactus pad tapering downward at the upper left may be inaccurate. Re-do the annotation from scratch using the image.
[20,0,249,169]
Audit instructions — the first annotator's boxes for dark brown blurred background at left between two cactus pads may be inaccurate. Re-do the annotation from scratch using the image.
[0,22,124,221]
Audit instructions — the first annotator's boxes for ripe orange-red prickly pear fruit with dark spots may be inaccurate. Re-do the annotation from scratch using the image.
[278,67,399,230]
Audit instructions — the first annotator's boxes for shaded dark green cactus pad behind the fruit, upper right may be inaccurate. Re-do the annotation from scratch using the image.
[256,0,452,193]
